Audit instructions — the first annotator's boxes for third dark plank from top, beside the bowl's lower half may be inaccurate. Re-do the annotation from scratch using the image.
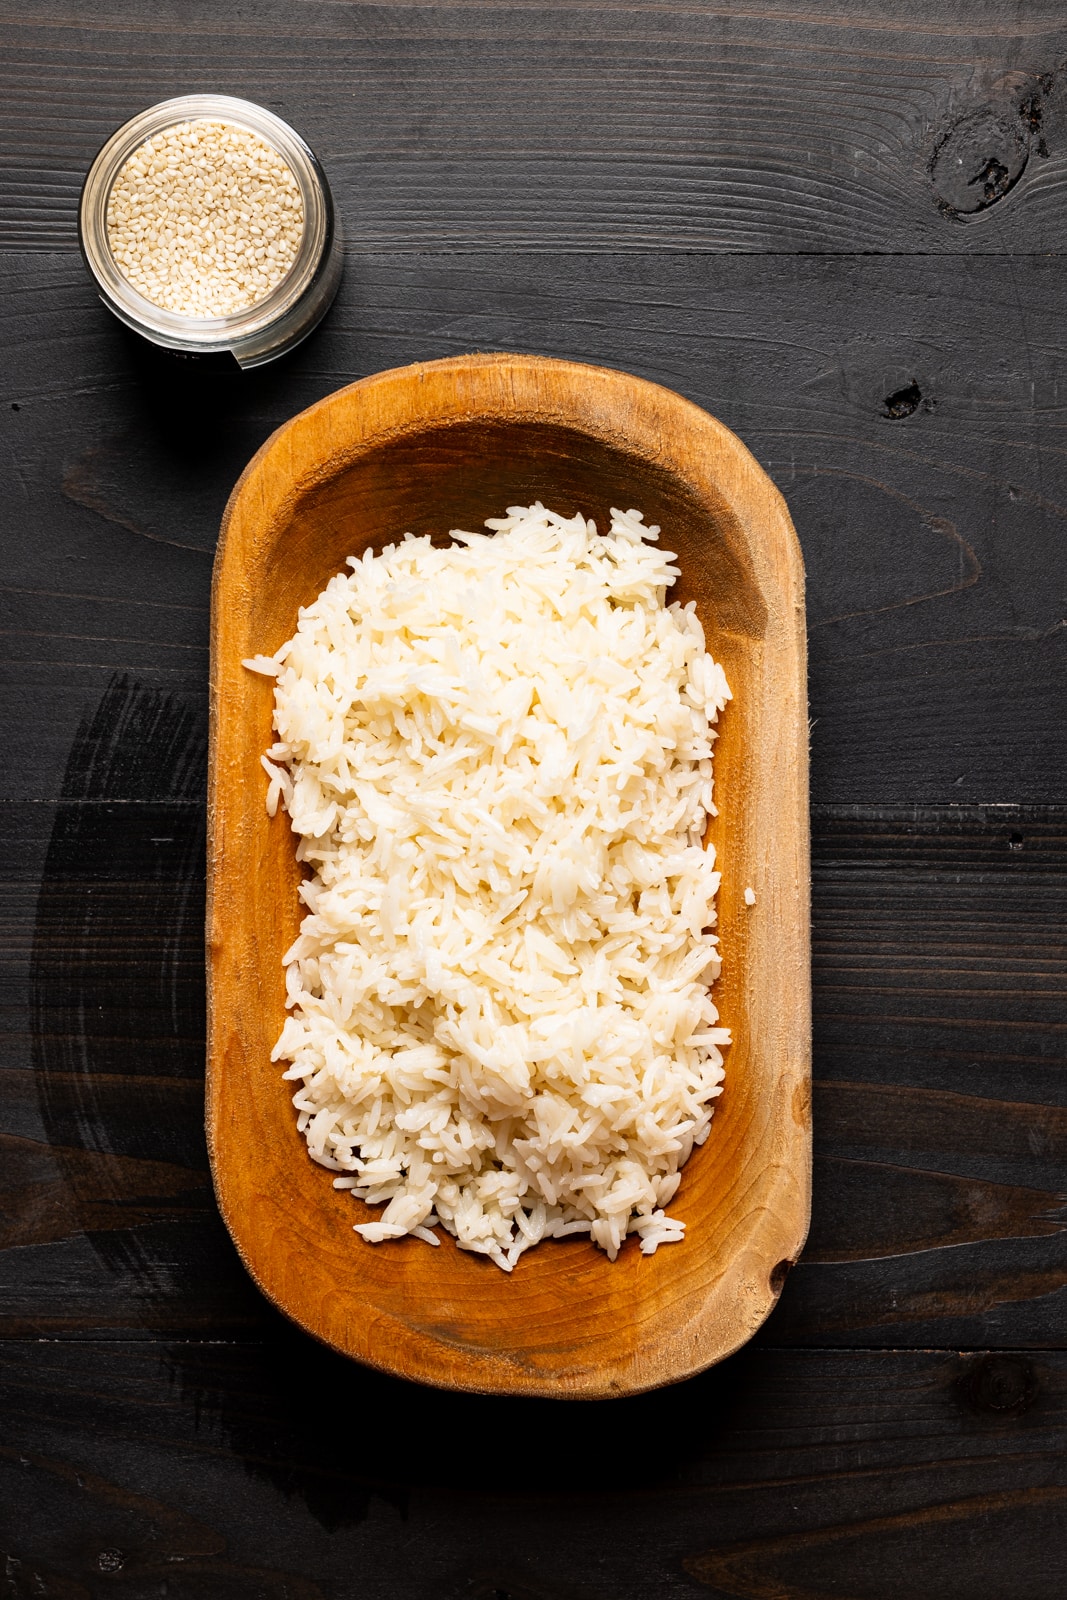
[0,796,1067,1347]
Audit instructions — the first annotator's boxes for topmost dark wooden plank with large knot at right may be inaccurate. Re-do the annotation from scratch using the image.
[0,0,1067,256]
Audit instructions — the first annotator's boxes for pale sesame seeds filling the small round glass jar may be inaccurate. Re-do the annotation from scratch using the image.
[107,118,304,317]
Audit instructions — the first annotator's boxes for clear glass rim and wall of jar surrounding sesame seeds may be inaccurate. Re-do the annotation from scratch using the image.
[78,94,342,366]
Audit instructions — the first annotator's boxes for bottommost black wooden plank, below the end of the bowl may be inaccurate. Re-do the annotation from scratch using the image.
[0,1344,1067,1600]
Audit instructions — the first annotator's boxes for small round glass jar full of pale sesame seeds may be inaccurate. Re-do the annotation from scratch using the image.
[78,94,342,366]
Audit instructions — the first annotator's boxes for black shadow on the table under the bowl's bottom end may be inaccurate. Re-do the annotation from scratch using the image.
[168,1306,757,1530]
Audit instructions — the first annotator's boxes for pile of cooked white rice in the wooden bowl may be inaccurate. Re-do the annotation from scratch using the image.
[245,504,729,1270]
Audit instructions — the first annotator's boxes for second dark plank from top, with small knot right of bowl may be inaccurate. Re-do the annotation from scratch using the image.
[0,251,1067,806]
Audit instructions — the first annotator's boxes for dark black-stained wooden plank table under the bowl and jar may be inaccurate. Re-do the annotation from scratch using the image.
[0,0,1067,1600]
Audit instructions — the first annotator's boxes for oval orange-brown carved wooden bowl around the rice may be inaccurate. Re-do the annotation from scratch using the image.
[208,355,811,1398]
